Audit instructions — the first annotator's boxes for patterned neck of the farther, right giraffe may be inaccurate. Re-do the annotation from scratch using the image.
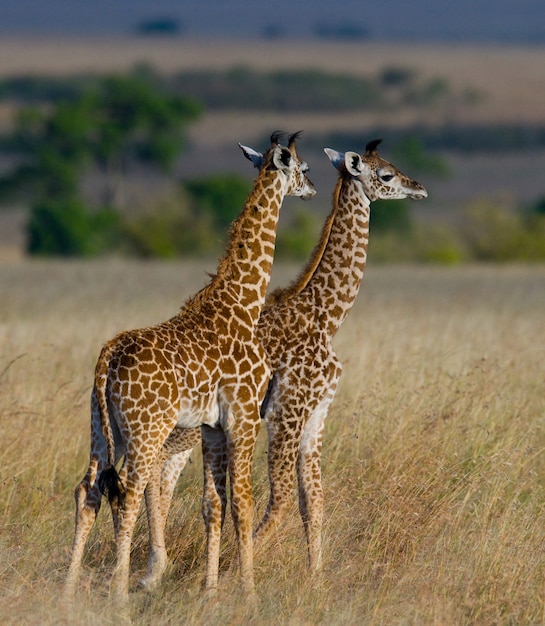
[300,174,370,336]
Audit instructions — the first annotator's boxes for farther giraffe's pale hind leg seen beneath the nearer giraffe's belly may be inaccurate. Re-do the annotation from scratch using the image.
[139,450,192,589]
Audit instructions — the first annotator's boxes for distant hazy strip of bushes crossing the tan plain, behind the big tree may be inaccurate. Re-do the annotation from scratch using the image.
[0,64,468,112]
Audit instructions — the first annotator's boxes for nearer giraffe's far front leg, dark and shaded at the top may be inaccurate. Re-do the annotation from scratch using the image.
[202,426,227,593]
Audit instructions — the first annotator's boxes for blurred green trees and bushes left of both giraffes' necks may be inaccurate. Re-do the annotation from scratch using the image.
[0,75,254,257]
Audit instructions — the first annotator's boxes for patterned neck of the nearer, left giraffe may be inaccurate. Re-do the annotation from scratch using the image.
[211,168,288,325]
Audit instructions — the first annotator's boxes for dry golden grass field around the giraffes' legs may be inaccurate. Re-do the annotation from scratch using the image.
[0,262,545,625]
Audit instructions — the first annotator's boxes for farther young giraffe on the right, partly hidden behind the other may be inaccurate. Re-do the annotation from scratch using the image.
[141,140,427,586]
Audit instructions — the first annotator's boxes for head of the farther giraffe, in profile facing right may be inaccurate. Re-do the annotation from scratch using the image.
[324,139,428,201]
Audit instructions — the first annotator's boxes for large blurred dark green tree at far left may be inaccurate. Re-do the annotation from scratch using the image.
[0,75,200,255]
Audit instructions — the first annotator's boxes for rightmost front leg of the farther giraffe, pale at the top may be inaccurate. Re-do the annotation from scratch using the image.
[297,380,337,572]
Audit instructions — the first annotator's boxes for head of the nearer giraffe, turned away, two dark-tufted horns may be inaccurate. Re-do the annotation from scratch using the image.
[238,131,316,200]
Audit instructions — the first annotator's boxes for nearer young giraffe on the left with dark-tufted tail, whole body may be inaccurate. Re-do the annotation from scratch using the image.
[65,133,316,602]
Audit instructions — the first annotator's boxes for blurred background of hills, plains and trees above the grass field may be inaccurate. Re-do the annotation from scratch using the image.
[0,0,545,264]
